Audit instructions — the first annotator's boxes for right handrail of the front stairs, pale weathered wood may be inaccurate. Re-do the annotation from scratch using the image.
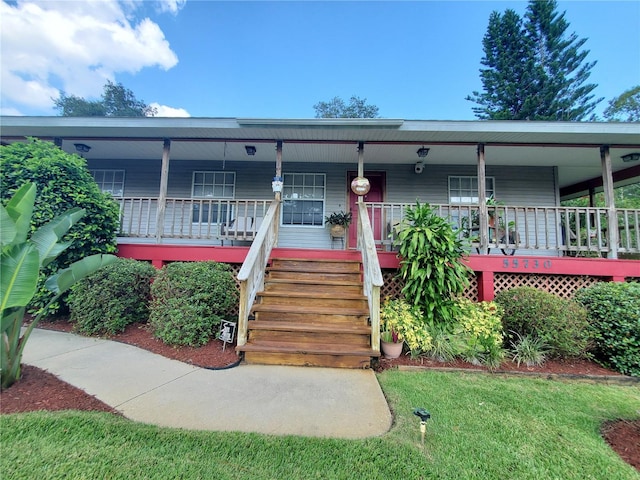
[358,202,384,352]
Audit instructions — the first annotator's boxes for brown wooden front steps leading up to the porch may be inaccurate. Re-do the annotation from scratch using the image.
[237,258,379,368]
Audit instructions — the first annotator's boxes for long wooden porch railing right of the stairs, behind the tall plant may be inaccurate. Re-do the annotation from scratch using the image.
[366,202,640,255]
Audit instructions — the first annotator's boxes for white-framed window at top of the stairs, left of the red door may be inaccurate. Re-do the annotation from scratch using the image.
[282,173,326,227]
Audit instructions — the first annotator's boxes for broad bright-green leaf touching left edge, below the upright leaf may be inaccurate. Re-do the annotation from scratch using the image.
[0,243,40,312]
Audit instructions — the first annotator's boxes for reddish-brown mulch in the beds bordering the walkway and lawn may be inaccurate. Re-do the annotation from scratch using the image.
[0,320,640,470]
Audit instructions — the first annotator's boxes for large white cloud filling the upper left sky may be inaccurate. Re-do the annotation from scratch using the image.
[0,0,184,109]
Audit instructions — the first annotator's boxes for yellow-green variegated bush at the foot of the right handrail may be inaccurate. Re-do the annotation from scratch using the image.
[380,298,431,356]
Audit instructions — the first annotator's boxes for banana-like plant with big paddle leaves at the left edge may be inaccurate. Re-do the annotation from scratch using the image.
[0,183,116,388]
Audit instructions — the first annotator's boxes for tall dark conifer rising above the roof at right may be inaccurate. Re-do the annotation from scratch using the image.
[466,0,602,121]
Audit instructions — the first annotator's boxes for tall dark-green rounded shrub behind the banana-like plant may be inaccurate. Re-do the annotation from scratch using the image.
[0,139,119,315]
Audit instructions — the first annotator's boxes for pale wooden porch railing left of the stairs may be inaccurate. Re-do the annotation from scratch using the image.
[118,197,271,241]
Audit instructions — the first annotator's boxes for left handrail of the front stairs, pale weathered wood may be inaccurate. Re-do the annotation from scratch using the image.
[236,199,280,346]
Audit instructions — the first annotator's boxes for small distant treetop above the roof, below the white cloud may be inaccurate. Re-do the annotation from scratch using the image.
[53,81,157,117]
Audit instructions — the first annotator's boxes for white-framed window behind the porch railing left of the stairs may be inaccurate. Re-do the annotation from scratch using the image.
[191,172,236,223]
